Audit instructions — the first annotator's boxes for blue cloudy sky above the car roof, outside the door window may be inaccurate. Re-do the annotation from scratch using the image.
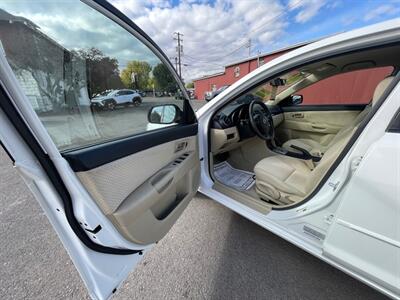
[111,0,400,81]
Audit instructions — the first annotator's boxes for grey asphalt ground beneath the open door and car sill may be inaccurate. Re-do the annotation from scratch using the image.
[0,146,384,299]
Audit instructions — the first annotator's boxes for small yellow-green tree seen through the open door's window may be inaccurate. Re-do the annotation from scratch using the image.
[121,60,151,90]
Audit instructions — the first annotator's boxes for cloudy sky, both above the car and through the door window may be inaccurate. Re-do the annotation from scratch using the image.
[0,0,400,82]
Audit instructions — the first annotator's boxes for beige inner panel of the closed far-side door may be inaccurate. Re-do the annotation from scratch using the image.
[277,105,365,144]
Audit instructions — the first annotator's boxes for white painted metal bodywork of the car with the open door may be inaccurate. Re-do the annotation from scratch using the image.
[0,3,400,299]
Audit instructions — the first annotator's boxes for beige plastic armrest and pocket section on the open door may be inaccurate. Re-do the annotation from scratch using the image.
[109,151,200,244]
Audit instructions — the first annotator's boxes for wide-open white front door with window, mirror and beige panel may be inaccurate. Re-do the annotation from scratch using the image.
[0,0,200,299]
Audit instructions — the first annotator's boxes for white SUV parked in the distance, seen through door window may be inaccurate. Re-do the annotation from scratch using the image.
[90,89,142,110]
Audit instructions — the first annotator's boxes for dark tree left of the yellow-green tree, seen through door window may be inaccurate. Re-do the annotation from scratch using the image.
[75,47,124,96]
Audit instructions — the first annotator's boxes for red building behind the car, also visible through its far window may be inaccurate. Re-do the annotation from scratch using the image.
[193,43,393,104]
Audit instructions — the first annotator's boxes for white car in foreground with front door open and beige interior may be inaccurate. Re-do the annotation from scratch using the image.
[0,1,400,299]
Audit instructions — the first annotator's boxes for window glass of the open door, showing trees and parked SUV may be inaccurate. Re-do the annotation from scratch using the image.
[0,1,183,150]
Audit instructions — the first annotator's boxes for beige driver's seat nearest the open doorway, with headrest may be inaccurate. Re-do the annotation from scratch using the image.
[254,77,393,205]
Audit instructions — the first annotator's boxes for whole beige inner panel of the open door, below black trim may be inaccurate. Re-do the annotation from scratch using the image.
[76,136,200,244]
